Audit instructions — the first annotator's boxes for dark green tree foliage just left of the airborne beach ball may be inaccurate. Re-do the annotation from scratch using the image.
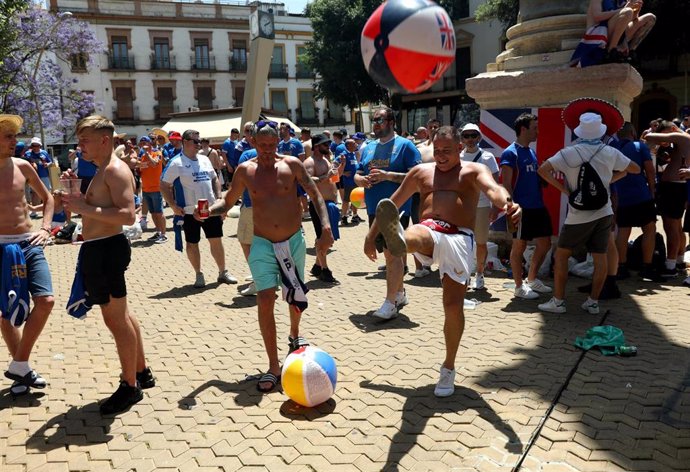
[305,0,388,108]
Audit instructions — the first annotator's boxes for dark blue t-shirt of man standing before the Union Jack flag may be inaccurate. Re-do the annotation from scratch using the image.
[501,143,544,209]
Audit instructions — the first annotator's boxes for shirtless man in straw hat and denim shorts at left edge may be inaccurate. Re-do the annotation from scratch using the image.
[0,115,54,396]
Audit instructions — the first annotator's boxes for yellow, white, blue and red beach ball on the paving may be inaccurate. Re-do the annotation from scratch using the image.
[281,346,338,407]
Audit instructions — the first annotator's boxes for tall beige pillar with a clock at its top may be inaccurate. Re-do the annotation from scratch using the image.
[242,8,275,126]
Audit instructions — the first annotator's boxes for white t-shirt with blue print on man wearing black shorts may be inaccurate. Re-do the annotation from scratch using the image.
[161,154,216,215]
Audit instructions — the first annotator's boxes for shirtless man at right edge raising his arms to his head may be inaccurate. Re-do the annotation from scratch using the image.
[645,121,690,277]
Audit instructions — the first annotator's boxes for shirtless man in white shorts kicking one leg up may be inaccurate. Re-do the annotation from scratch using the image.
[364,126,521,397]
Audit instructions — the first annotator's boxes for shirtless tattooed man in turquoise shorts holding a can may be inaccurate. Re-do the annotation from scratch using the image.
[204,121,333,393]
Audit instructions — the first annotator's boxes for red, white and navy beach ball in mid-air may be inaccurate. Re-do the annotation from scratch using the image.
[360,0,455,93]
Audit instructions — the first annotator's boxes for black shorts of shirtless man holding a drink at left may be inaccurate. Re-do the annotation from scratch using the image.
[79,234,132,305]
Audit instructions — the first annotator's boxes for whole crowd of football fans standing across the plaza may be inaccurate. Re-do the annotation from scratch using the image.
[0,98,690,414]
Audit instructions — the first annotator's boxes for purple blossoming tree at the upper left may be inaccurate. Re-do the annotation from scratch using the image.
[0,1,105,142]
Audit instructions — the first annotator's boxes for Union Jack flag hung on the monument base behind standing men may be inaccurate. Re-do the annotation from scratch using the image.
[479,108,573,234]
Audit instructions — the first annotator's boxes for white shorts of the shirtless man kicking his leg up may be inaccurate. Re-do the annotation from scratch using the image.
[414,225,474,285]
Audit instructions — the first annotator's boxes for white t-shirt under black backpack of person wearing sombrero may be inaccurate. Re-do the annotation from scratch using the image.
[548,143,630,225]
